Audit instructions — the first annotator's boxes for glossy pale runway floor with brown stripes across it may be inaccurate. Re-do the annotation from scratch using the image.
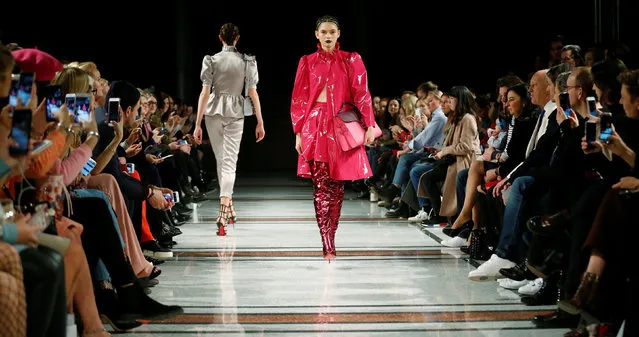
[115,174,567,337]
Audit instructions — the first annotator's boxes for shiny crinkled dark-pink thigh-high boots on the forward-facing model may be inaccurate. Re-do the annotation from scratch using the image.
[311,162,344,262]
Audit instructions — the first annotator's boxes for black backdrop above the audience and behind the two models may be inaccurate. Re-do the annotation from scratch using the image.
[0,0,639,171]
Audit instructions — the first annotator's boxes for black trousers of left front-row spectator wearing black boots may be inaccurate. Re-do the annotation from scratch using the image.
[71,198,136,286]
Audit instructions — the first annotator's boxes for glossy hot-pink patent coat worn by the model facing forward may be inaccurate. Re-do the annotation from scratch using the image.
[291,43,375,180]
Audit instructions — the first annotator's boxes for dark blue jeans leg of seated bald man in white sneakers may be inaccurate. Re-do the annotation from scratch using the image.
[495,176,535,262]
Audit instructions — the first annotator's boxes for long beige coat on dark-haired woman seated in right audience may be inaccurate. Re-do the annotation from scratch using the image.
[418,114,481,217]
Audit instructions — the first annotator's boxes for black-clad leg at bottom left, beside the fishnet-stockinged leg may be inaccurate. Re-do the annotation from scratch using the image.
[20,246,67,337]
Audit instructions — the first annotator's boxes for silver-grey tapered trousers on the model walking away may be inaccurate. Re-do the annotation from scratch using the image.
[204,115,244,198]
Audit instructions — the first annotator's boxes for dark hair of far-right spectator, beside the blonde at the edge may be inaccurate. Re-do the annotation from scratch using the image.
[590,59,627,104]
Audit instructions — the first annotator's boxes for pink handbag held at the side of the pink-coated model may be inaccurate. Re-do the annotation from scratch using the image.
[333,102,382,152]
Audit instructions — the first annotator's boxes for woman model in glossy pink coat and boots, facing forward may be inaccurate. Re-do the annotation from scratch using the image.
[291,16,375,261]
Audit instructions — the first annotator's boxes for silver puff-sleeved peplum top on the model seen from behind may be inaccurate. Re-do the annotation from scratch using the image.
[200,46,259,118]
